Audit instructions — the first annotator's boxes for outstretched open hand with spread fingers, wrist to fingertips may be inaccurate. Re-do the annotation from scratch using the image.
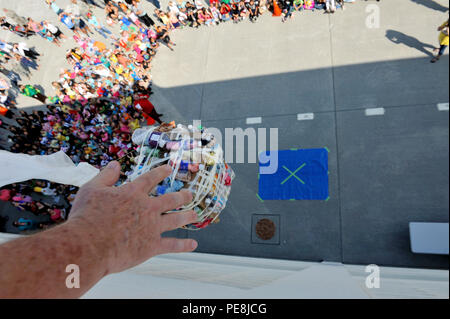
[68,161,197,274]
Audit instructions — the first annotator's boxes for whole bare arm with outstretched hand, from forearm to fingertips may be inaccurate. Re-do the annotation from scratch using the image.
[0,162,197,298]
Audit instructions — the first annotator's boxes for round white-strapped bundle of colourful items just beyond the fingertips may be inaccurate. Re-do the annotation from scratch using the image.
[127,123,234,230]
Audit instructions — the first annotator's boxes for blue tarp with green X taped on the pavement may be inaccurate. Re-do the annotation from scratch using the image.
[258,148,329,200]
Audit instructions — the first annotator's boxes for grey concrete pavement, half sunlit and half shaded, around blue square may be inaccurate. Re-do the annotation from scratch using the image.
[149,0,449,268]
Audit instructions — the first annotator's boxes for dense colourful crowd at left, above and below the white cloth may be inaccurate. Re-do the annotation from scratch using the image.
[0,0,171,230]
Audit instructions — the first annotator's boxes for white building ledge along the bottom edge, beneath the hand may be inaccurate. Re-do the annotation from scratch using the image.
[0,233,449,299]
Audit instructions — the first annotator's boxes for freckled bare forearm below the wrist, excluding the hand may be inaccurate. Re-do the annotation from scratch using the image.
[0,216,107,298]
